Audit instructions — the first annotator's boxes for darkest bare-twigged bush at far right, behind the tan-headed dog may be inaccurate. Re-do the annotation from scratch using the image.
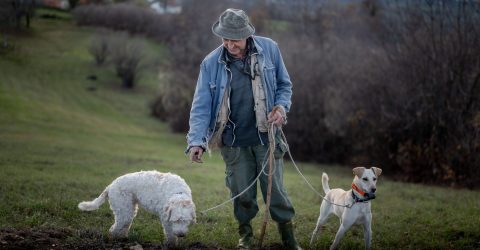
[338,1,480,187]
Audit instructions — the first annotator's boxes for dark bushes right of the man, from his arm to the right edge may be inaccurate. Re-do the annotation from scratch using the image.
[279,1,480,187]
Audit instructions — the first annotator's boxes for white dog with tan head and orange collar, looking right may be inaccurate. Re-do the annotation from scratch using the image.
[310,167,382,249]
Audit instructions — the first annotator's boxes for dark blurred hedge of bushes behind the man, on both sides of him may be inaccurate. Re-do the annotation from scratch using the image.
[71,0,480,188]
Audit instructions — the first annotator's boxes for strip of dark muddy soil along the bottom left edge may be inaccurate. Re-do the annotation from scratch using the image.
[0,228,281,250]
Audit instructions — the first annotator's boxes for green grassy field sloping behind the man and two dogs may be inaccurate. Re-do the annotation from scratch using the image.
[0,8,480,249]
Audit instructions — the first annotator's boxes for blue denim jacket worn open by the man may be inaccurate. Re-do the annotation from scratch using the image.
[187,36,292,151]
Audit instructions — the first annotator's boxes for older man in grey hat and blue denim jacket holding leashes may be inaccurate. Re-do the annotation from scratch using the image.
[187,9,301,249]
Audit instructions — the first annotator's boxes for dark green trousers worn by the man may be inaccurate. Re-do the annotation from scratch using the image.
[221,145,295,224]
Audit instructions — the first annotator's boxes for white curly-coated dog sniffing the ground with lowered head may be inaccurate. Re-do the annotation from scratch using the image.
[78,171,196,245]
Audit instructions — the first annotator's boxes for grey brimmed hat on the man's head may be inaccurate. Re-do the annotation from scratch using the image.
[212,9,255,40]
